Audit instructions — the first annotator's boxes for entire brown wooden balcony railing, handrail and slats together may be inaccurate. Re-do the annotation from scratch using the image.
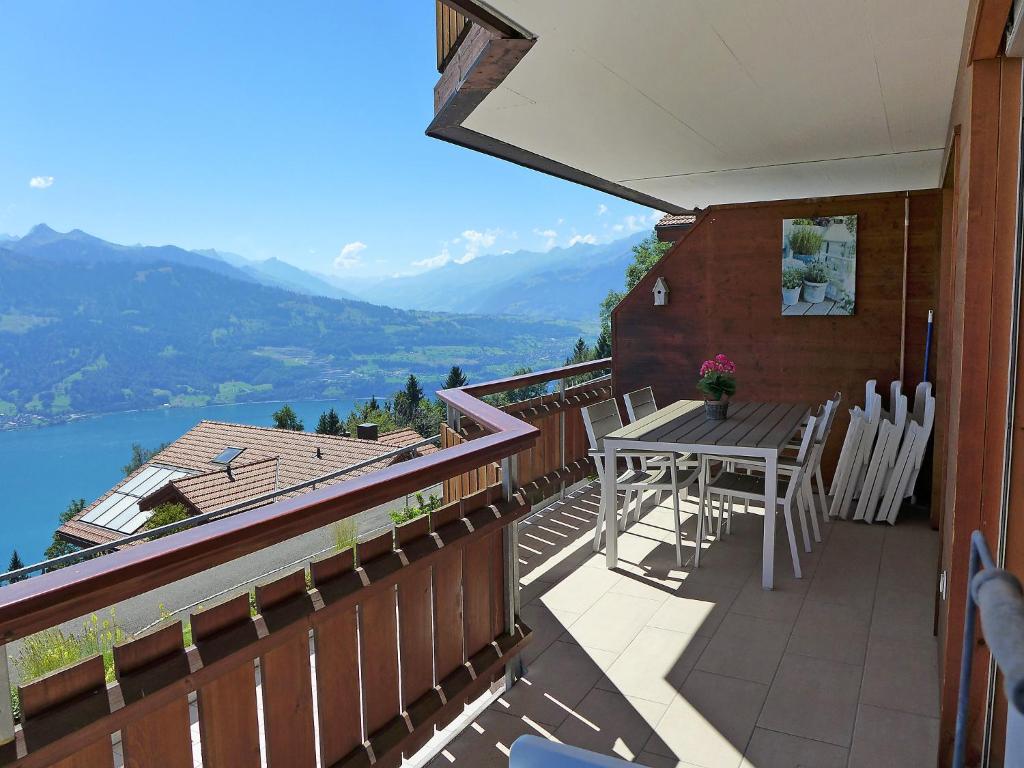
[0,360,609,767]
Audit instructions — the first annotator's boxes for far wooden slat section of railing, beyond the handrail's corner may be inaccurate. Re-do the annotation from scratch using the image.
[441,379,611,503]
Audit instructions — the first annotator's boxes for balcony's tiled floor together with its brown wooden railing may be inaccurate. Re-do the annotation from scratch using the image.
[0,360,938,768]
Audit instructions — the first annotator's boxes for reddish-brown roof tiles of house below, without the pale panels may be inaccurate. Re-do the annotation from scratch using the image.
[59,421,436,544]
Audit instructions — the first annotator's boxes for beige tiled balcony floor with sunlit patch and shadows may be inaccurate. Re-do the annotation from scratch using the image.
[430,486,939,768]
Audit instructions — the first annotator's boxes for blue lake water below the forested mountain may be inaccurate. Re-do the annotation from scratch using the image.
[0,400,353,571]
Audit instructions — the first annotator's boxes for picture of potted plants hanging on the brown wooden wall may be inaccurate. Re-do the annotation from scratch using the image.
[782,216,857,317]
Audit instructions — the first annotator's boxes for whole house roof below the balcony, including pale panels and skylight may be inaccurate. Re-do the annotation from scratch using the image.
[57,421,435,547]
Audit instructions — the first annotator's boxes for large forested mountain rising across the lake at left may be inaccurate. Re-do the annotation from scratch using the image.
[0,236,580,421]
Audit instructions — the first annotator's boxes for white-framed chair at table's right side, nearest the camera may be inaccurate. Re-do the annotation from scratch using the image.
[697,409,822,579]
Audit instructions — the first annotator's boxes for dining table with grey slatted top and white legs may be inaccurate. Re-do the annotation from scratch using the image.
[601,400,811,590]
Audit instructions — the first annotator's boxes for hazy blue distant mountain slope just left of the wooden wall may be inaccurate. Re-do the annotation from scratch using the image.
[348,232,646,324]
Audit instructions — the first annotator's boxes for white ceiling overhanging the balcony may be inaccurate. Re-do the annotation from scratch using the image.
[464,0,968,208]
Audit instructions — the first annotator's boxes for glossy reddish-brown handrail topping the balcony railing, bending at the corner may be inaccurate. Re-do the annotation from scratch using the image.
[0,358,610,643]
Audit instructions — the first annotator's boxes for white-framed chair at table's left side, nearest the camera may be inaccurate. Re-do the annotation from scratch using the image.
[581,399,698,567]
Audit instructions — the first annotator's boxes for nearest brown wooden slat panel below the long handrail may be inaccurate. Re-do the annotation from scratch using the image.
[8,482,530,768]
